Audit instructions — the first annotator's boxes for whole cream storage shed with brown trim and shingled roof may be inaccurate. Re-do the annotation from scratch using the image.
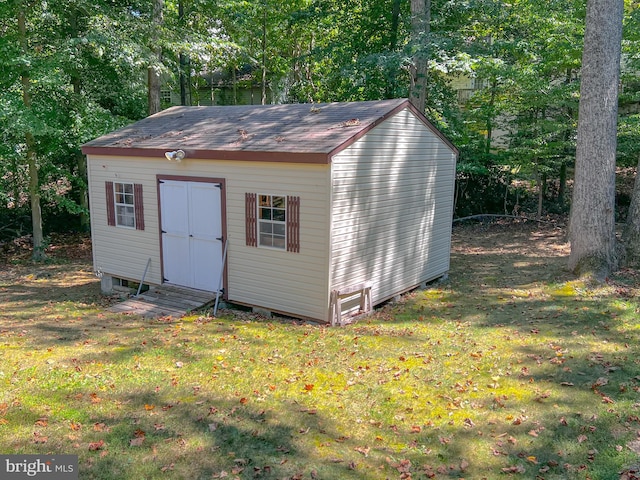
[82,99,457,324]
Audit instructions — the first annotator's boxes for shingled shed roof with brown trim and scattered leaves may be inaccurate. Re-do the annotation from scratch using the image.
[82,99,457,163]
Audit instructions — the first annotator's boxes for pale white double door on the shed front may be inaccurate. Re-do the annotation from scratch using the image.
[160,180,224,292]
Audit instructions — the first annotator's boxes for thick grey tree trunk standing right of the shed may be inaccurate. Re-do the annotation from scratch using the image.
[569,0,623,281]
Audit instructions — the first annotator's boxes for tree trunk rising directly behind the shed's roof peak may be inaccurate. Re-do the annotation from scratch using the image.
[409,0,431,113]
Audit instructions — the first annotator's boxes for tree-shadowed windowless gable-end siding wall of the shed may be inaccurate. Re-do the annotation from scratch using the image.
[330,110,455,304]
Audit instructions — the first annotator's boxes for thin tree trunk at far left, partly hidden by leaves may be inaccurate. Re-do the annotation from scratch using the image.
[18,6,46,261]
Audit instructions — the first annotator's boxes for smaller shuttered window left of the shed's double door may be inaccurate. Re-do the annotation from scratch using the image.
[105,182,144,230]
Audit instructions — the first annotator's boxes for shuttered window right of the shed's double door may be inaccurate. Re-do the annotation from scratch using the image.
[245,193,300,252]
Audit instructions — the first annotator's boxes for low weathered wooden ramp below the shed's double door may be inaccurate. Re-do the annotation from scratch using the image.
[109,285,216,317]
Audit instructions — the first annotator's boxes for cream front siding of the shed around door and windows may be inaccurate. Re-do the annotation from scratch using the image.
[88,155,330,321]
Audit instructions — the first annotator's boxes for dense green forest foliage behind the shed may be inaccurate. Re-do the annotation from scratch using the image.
[0,0,640,246]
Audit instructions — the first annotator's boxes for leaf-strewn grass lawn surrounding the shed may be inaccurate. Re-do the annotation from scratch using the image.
[0,224,640,480]
